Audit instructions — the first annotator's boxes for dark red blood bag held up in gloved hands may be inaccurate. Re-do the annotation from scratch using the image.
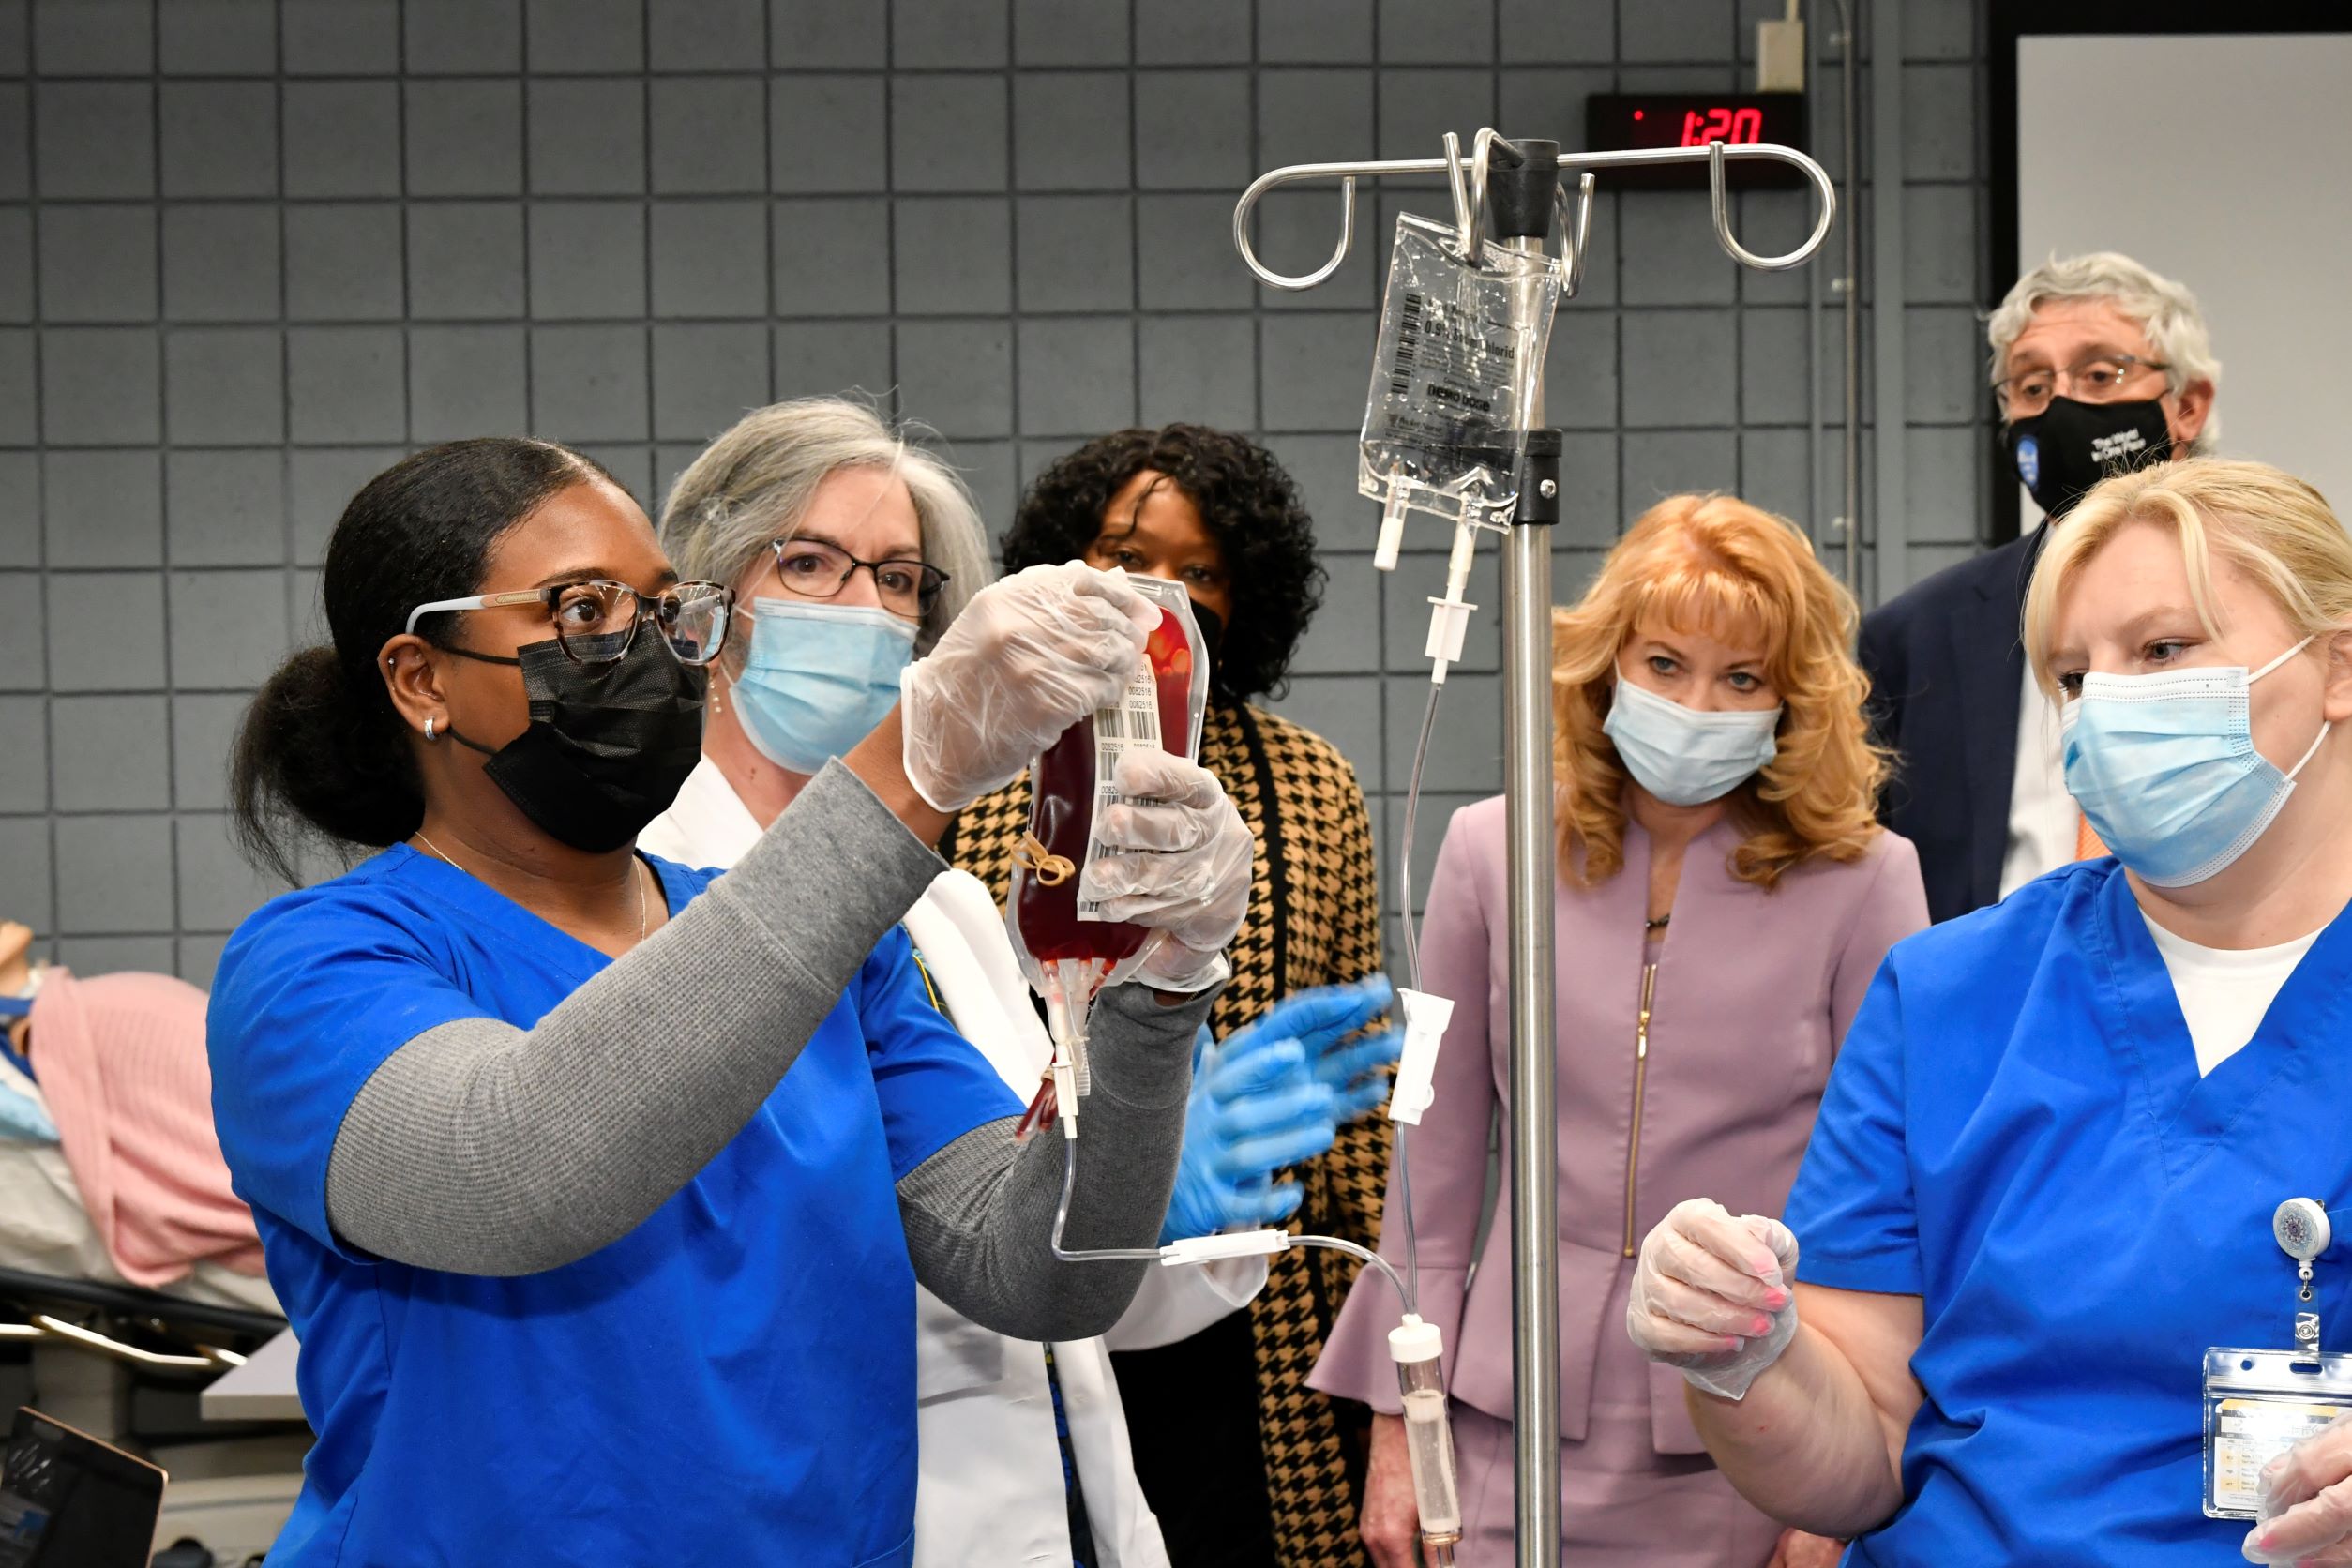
[1004,576,1209,1131]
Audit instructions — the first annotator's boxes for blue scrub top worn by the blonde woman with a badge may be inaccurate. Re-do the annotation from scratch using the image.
[1787,860,2352,1568]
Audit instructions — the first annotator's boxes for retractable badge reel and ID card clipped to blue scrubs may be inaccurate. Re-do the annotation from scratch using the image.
[2204,1199,2352,1518]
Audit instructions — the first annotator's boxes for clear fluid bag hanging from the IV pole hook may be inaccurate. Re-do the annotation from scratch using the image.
[1357,212,1561,527]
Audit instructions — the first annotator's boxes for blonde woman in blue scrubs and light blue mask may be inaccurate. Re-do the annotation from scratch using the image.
[1628,459,2352,1568]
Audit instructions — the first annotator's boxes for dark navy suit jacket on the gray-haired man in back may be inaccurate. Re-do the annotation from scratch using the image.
[1861,527,2046,919]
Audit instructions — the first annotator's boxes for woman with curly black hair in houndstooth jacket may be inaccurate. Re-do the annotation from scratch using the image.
[941,426,1388,1568]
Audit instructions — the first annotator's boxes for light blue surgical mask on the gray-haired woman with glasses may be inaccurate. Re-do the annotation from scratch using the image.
[733,599,917,774]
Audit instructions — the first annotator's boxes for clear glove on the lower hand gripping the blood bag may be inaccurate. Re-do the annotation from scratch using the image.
[1081,747,1259,992]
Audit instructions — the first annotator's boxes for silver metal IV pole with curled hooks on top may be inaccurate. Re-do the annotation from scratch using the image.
[1232,129,1837,1568]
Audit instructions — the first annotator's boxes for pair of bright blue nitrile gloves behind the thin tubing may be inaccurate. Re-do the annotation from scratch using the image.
[1159,975,1397,1244]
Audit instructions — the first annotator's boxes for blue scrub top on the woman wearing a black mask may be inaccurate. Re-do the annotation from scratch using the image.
[209,846,1020,1568]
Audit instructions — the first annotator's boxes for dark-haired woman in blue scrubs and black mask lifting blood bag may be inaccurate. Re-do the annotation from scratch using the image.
[207,440,1246,1568]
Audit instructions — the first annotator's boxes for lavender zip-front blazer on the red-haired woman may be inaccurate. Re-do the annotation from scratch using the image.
[1307,799,1926,1453]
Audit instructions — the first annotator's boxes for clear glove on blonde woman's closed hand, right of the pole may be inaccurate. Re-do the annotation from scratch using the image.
[1625,1199,1797,1399]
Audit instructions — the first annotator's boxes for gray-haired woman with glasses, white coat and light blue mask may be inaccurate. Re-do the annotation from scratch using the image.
[640,398,1385,1568]
